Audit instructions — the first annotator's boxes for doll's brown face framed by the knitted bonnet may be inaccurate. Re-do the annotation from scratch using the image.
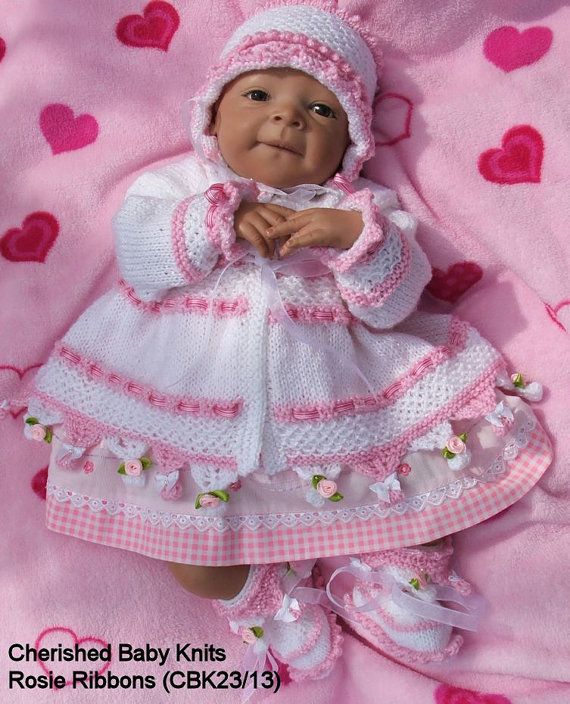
[210,68,350,188]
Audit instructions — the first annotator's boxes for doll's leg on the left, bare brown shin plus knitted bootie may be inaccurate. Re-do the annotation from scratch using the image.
[169,563,342,680]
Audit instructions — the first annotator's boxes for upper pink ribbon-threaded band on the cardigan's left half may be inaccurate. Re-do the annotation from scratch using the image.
[119,279,249,318]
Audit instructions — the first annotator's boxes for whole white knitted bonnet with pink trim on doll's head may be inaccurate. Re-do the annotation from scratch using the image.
[190,3,381,182]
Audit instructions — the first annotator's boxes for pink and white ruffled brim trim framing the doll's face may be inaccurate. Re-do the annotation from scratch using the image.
[199,30,376,181]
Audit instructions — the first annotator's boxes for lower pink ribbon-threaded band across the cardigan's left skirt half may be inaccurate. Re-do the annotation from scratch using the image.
[54,342,243,419]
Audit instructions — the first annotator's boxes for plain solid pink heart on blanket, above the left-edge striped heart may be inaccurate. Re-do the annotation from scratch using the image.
[40,103,99,154]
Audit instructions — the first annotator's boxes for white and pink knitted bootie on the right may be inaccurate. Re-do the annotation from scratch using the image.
[332,537,471,663]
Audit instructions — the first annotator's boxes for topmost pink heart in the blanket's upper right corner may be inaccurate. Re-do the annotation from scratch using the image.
[483,27,552,73]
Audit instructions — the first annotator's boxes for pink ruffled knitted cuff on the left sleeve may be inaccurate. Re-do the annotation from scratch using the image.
[204,181,257,260]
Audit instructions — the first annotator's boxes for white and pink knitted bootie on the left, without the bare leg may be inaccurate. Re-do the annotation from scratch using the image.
[214,563,342,681]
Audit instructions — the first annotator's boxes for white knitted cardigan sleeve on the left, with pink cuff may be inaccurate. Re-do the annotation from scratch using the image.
[113,156,255,300]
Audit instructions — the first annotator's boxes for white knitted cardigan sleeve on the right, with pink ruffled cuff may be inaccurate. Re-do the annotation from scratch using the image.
[319,179,431,328]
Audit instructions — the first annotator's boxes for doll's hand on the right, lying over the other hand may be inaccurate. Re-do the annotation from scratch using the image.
[266,208,364,256]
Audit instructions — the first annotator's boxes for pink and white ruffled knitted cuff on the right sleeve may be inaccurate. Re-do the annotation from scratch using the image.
[315,188,385,273]
